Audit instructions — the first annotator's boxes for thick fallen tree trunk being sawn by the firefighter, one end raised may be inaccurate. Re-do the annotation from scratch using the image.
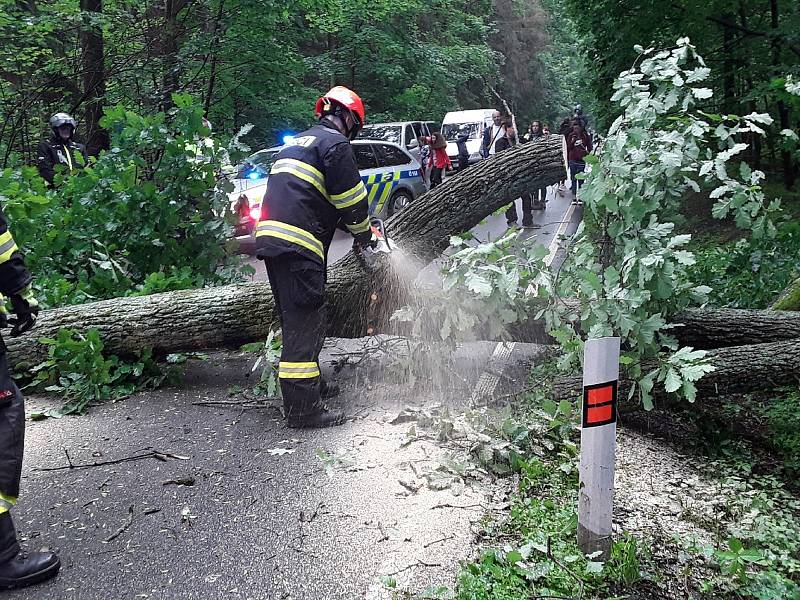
[7,136,566,368]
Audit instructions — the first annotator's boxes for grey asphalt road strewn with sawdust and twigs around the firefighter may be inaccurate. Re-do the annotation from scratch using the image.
[6,185,579,600]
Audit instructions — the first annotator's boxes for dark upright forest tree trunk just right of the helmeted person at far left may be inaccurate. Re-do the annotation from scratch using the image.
[81,0,110,156]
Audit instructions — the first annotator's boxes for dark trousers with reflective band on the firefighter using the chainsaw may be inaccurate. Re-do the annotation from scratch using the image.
[264,254,328,418]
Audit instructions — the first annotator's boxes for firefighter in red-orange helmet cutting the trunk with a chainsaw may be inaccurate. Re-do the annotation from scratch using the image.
[256,86,378,427]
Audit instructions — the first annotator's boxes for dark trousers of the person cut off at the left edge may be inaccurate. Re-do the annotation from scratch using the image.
[0,350,25,563]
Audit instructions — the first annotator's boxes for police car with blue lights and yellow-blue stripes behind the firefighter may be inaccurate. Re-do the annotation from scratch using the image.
[229,139,427,237]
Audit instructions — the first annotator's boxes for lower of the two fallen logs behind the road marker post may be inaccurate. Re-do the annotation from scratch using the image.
[553,340,800,409]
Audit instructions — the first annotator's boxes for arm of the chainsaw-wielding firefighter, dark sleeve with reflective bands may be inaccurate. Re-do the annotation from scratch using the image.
[323,142,372,246]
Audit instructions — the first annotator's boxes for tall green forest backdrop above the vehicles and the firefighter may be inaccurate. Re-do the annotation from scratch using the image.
[0,0,585,166]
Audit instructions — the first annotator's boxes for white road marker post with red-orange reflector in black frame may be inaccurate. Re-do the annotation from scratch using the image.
[578,337,619,559]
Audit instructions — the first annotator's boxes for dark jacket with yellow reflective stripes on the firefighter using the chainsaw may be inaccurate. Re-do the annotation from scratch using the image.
[256,121,370,264]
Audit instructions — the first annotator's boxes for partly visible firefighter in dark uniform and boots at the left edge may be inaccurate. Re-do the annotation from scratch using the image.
[0,206,61,589]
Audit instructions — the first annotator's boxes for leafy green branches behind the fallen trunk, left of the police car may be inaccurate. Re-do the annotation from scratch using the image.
[0,96,245,306]
